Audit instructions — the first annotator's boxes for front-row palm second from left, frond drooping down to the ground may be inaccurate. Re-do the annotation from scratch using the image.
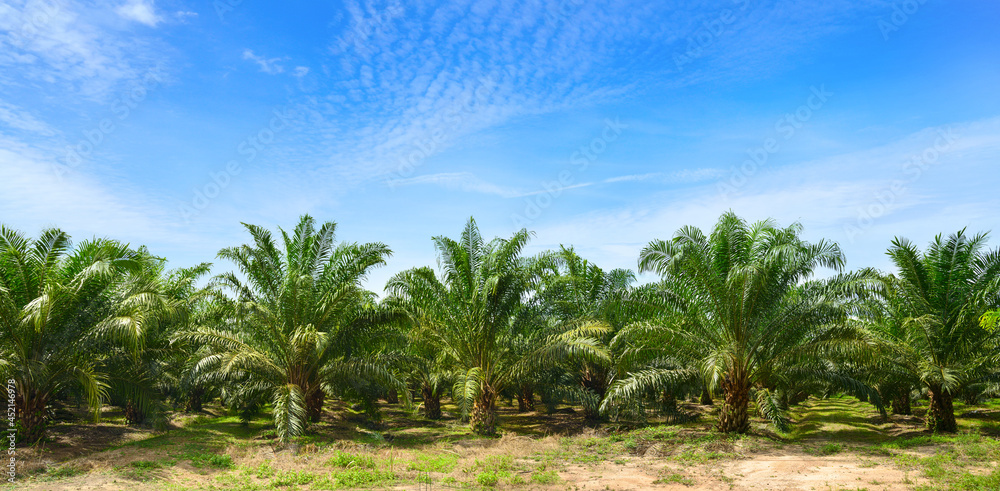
[184,215,402,442]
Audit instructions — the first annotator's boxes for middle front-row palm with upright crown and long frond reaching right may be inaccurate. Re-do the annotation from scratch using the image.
[386,218,606,435]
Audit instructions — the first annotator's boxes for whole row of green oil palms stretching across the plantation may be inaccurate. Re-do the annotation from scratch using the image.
[0,212,1000,441]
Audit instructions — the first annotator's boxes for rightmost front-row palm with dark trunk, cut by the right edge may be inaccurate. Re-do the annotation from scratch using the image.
[868,230,1000,433]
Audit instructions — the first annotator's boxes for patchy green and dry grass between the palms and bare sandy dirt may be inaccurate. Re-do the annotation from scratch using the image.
[17,398,1000,491]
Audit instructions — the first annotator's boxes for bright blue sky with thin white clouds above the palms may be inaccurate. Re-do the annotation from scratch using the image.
[0,0,1000,291]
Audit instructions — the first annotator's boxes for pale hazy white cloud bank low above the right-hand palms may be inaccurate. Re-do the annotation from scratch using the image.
[532,118,1000,276]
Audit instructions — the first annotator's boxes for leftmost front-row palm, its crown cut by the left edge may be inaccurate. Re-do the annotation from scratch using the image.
[0,226,164,441]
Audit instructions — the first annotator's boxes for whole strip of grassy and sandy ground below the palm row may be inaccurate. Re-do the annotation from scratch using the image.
[7,398,1000,491]
